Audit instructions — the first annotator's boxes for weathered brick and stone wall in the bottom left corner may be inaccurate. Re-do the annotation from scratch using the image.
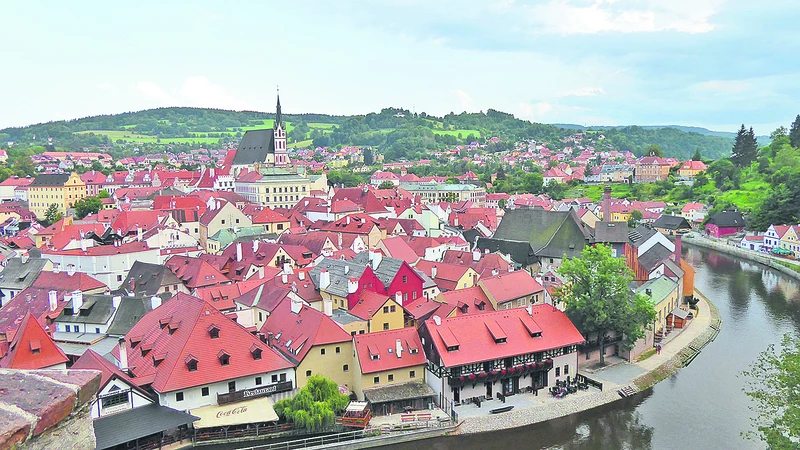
[0,369,100,450]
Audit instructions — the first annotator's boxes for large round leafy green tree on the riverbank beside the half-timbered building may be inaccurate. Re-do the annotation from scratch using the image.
[555,245,656,364]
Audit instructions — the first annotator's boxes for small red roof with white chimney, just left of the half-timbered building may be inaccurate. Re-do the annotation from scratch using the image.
[355,327,426,374]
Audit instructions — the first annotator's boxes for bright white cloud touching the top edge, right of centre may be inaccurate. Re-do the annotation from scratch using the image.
[528,0,722,34]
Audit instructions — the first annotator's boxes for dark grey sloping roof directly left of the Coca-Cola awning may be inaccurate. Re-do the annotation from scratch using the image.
[94,403,197,449]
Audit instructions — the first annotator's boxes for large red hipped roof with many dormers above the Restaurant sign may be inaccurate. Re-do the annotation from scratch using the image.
[119,293,292,392]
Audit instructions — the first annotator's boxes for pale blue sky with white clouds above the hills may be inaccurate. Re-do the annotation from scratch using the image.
[0,0,800,134]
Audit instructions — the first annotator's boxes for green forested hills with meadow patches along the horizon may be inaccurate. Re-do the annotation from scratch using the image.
[0,107,732,160]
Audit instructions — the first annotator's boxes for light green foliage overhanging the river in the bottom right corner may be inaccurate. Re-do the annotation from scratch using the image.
[742,335,800,449]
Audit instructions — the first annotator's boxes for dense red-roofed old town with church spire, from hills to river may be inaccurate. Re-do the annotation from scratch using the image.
[0,97,788,448]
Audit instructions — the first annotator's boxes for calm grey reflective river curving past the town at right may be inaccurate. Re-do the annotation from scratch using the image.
[385,246,800,450]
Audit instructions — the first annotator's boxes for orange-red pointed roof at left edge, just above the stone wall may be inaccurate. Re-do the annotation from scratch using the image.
[0,312,69,369]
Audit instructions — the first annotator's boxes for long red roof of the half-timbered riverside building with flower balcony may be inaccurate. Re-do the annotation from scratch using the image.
[425,305,584,367]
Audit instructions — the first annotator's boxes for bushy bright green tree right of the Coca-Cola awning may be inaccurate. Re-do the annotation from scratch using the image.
[275,375,350,433]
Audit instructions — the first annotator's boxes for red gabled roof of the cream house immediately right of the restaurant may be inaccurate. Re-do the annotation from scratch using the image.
[261,297,352,362]
